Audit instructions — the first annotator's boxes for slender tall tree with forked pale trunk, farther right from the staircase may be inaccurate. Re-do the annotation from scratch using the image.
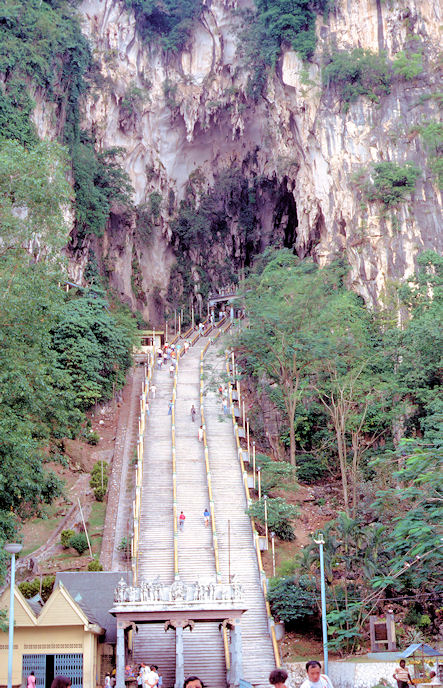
[310,289,395,518]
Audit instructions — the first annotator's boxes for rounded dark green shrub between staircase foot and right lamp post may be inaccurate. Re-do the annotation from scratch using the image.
[268,576,318,625]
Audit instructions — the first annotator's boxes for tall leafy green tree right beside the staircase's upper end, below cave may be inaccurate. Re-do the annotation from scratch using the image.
[237,250,343,466]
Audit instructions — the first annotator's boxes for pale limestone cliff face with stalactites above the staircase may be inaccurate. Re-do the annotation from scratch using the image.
[61,0,443,323]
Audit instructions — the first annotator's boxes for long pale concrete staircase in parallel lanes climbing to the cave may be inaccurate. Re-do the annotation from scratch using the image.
[133,332,274,688]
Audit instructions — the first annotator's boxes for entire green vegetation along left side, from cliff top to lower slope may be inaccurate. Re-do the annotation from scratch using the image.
[0,0,135,577]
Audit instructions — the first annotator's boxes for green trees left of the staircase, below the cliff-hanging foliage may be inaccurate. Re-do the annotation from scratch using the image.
[0,133,134,580]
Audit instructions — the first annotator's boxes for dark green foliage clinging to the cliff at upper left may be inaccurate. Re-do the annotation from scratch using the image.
[0,0,132,239]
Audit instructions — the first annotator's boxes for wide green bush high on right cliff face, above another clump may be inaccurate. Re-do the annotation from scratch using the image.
[323,48,391,111]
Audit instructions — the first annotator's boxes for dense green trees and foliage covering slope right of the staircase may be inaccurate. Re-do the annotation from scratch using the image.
[237,251,443,650]
